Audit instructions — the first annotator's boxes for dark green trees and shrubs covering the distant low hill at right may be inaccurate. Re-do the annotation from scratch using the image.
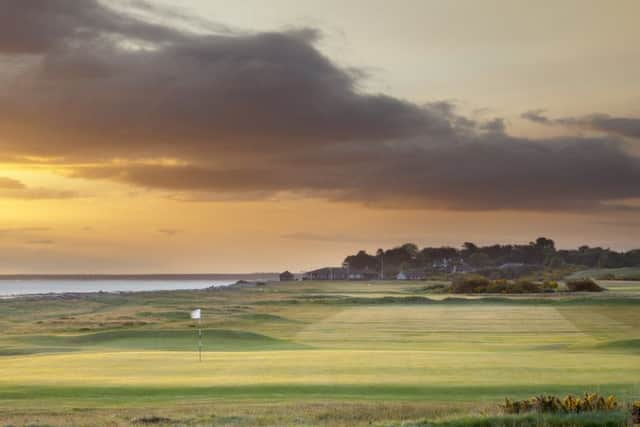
[344,237,640,281]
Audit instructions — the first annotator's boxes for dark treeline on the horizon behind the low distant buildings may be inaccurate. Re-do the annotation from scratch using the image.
[344,237,640,277]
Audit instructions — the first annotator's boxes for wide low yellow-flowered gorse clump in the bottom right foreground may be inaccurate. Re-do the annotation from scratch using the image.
[502,393,619,414]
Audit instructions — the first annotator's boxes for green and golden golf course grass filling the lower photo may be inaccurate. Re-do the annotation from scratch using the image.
[0,281,640,426]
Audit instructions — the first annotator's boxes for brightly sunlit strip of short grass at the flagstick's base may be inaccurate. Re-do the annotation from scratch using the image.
[0,349,640,397]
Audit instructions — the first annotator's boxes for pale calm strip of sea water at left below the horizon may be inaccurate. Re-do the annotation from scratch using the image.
[0,279,236,297]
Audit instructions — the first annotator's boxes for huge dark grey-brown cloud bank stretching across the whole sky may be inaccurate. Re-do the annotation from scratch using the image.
[0,1,640,210]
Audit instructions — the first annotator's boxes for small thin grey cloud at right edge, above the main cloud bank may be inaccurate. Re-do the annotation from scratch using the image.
[521,110,640,139]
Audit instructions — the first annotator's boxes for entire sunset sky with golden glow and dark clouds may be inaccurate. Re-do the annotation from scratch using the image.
[0,0,640,273]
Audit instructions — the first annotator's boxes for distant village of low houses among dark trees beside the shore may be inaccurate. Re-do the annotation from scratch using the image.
[280,237,640,281]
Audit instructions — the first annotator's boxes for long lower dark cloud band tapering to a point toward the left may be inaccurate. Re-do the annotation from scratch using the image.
[70,135,640,210]
